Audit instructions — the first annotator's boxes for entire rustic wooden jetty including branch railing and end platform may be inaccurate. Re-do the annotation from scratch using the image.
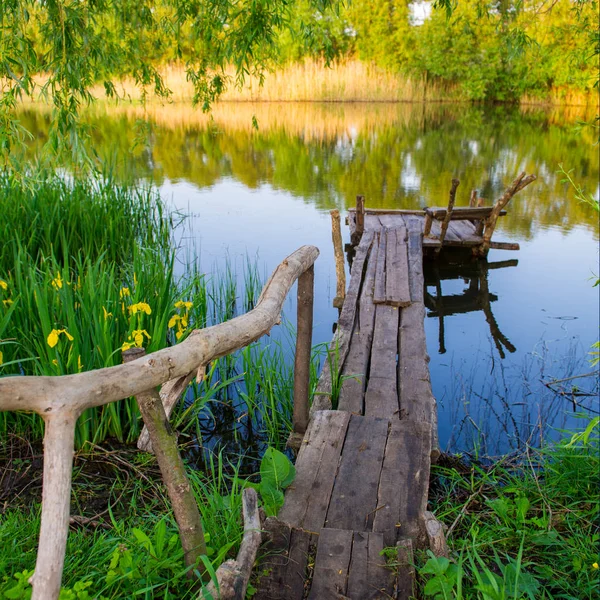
[0,173,535,600]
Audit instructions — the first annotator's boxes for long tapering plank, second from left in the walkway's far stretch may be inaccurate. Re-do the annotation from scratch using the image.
[337,239,378,414]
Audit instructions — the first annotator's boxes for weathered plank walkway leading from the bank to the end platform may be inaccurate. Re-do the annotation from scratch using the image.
[257,214,437,600]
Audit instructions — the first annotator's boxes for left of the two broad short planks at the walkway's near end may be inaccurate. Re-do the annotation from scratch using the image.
[308,529,353,600]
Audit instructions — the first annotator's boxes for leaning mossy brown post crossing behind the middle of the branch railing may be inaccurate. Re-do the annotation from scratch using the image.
[123,348,206,577]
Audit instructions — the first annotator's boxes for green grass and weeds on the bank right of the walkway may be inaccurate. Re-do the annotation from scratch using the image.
[419,421,600,600]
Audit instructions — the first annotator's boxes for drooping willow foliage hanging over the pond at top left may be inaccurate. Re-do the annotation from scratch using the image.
[0,0,338,163]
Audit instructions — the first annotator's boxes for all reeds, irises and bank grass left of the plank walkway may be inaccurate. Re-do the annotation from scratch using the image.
[0,172,304,599]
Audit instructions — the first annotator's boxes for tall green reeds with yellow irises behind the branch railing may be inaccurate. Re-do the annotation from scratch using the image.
[0,171,308,452]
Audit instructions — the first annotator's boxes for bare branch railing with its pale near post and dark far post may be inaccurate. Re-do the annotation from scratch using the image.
[0,246,319,600]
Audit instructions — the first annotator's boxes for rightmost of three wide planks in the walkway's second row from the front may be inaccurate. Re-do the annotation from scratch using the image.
[373,420,431,547]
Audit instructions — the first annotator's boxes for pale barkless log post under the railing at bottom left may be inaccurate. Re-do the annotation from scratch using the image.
[29,409,78,600]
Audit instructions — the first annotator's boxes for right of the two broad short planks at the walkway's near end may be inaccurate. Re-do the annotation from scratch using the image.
[346,532,394,600]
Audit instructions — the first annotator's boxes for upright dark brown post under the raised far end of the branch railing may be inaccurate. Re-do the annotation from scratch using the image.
[288,265,315,449]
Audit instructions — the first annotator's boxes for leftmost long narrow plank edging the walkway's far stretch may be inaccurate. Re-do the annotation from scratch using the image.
[310,231,373,414]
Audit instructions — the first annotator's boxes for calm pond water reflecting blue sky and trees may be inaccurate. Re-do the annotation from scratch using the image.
[23,104,599,454]
